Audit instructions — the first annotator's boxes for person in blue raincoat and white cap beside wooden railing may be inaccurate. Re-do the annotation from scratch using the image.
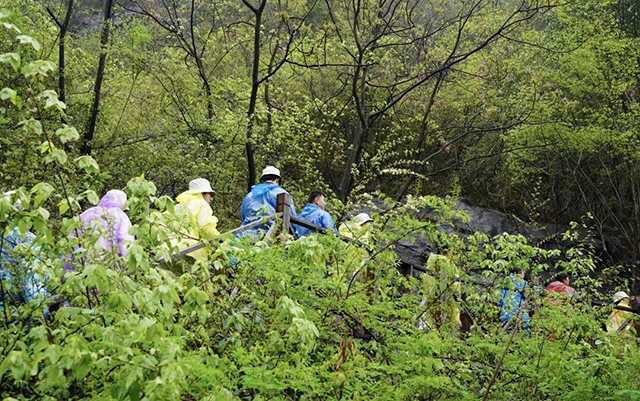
[236,166,296,240]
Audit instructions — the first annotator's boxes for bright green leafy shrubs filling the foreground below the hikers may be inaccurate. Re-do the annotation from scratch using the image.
[0,168,640,399]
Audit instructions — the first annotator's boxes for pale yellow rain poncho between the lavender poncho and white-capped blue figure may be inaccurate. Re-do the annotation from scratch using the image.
[171,190,220,259]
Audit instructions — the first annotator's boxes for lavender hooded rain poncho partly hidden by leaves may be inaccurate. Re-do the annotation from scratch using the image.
[71,189,135,256]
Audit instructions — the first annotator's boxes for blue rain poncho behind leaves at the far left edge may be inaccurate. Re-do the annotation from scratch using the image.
[0,228,47,309]
